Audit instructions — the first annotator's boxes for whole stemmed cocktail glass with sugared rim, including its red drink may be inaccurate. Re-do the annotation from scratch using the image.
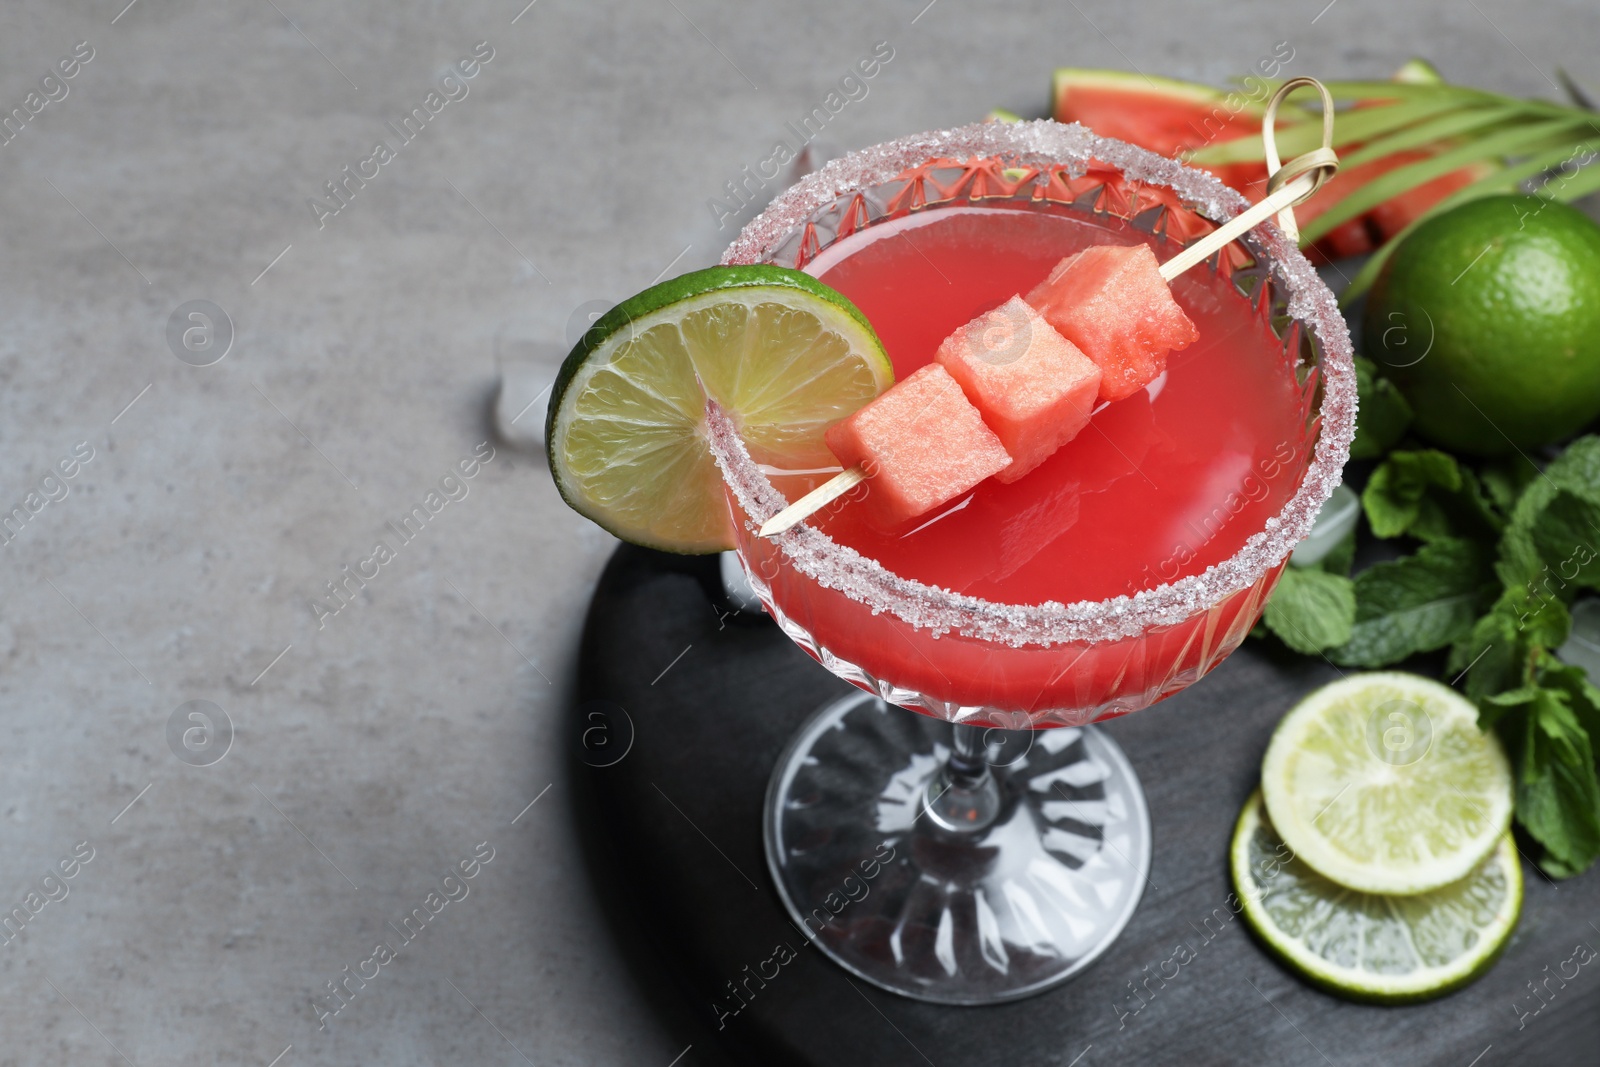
[706,122,1355,1005]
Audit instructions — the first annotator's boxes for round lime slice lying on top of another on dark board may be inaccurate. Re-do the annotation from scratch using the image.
[1261,672,1512,893]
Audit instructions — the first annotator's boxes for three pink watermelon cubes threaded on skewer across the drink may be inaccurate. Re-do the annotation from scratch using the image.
[760,243,1203,537]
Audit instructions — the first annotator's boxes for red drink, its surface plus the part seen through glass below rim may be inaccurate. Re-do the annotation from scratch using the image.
[779,208,1314,726]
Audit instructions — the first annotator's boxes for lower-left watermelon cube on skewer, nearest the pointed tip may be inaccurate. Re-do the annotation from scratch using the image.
[827,363,1011,525]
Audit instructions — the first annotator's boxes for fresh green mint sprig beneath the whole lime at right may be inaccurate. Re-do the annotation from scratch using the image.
[1258,367,1600,878]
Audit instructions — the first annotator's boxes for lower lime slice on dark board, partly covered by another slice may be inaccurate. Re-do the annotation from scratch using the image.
[1232,792,1522,1003]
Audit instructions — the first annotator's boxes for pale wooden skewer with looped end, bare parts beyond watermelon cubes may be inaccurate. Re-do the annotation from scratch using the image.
[757,78,1339,537]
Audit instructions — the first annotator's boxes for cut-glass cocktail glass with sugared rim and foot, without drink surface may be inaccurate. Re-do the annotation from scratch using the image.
[707,122,1355,1005]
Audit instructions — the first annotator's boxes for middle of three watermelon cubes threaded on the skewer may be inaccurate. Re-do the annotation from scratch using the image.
[934,296,1101,482]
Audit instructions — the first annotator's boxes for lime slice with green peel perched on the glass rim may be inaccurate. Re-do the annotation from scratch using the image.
[546,266,894,552]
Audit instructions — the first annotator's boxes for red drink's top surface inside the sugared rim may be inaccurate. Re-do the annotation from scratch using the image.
[808,208,1309,604]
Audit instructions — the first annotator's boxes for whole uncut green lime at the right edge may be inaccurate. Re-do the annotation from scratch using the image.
[1363,197,1600,456]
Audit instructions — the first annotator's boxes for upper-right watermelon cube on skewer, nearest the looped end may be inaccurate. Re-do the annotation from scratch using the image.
[1027,245,1200,400]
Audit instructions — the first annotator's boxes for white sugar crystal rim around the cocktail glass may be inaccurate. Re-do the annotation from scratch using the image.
[707,118,1355,646]
